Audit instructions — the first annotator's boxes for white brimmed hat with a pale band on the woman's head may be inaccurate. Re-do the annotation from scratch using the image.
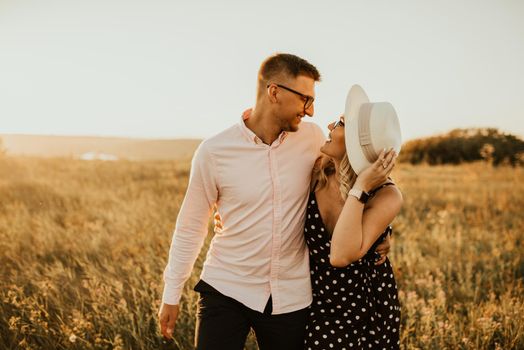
[344,85,402,175]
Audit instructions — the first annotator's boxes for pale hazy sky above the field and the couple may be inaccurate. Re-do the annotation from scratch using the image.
[0,0,524,140]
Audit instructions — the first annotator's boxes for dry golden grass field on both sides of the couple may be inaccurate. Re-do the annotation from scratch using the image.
[0,157,524,349]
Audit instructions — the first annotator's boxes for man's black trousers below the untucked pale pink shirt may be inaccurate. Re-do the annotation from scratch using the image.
[195,280,307,350]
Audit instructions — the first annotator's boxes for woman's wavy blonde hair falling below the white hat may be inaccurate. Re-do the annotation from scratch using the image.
[313,153,357,200]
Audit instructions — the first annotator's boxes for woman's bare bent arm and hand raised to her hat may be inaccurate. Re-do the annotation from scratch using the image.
[330,150,402,267]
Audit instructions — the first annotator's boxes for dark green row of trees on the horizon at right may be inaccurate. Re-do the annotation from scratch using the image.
[399,128,524,166]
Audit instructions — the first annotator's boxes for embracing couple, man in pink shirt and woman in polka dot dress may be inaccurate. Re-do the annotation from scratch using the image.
[159,54,402,350]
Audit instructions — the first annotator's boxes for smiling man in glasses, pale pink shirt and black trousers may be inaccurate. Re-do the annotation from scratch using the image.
[159,54,388,350]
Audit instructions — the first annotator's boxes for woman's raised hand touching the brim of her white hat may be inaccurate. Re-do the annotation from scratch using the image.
[354,148,397,192]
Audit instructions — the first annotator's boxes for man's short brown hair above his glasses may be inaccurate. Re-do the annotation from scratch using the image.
[258,53,320,88]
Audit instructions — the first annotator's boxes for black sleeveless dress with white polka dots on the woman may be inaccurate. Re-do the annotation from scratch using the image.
[304,184,400,350]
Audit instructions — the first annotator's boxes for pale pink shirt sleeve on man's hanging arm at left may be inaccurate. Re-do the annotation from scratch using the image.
[162,141,218,305]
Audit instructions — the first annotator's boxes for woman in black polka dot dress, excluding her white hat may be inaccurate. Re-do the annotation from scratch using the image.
[304,117,402,349]
